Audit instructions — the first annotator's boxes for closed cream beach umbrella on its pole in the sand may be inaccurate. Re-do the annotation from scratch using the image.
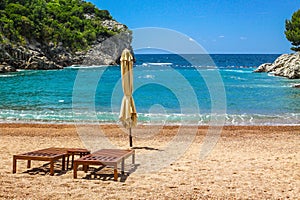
[119,49,137,147]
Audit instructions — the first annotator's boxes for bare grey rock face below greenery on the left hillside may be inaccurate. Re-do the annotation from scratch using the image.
[0,20,132,73]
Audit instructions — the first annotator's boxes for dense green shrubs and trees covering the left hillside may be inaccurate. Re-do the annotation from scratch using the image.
[0,0,118,52]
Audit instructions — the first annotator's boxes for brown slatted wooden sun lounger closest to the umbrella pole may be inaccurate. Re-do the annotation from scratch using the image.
[73,149,135,181]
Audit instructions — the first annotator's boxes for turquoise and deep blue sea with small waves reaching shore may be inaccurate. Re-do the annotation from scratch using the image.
[0,54,300,125]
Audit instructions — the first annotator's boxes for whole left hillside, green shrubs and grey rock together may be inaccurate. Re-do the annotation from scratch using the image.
[0,0,131,72]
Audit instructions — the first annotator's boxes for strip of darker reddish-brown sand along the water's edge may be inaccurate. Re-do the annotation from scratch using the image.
[0,123,300,139]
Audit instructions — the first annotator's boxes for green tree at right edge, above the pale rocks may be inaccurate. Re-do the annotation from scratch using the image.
[285,10,300,51]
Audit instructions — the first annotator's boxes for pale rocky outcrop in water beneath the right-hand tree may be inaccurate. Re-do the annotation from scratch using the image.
[254,53,300,79]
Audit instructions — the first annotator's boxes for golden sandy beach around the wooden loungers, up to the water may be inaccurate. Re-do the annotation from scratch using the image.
[0,124,300,199]
